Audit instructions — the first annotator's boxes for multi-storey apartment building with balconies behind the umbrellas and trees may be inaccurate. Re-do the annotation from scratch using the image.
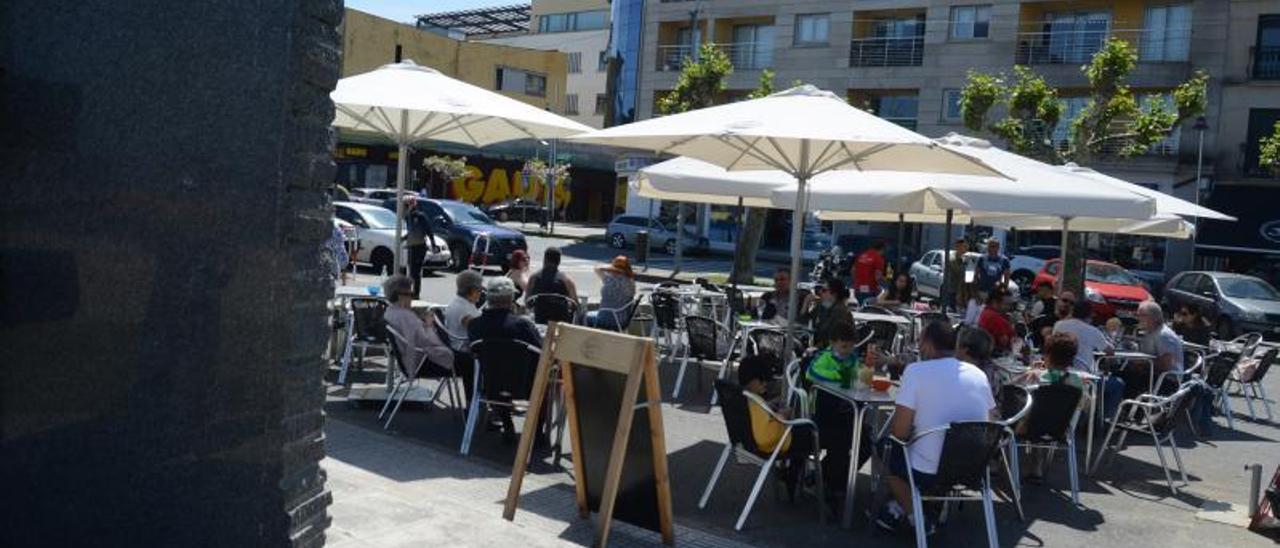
[613,0,1280,280]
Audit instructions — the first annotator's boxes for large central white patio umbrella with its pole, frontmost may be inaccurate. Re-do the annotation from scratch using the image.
[571,86,1001,346]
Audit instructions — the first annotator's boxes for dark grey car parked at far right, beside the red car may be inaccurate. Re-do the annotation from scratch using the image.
[1162,271,1280,341]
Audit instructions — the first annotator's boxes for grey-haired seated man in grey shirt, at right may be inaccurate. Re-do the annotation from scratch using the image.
[1102,301,1183,417]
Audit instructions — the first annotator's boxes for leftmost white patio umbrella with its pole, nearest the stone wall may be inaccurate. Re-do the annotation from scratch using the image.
[329,60,591,271]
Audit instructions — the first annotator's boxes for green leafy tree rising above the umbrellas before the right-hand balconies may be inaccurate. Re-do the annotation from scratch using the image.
[960,38,1208,294]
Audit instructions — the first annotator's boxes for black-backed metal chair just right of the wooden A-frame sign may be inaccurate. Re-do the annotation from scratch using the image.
[698,379,826,531]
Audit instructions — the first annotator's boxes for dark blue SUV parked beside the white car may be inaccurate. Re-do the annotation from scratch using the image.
[383,198,529,271]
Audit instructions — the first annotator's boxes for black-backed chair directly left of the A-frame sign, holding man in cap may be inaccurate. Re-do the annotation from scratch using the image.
[460,339,541,455]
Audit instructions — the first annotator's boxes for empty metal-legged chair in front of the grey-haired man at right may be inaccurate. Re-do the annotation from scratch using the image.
[1089,380,1198,496]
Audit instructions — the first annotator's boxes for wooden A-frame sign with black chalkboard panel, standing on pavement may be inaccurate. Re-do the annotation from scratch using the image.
[502,323,675,548]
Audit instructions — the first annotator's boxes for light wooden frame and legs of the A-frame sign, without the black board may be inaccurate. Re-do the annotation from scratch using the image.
[502,323,675,548]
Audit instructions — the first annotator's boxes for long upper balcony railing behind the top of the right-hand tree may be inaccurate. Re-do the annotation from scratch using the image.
[1015,27,1192,65]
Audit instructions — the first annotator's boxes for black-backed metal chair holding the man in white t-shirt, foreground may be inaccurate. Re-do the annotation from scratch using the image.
[890,421,1007,548]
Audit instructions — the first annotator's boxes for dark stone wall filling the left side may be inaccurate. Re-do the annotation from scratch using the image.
[0,0,343,547]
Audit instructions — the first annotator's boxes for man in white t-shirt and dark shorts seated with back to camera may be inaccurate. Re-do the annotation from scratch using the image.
[876,321,996,531]
